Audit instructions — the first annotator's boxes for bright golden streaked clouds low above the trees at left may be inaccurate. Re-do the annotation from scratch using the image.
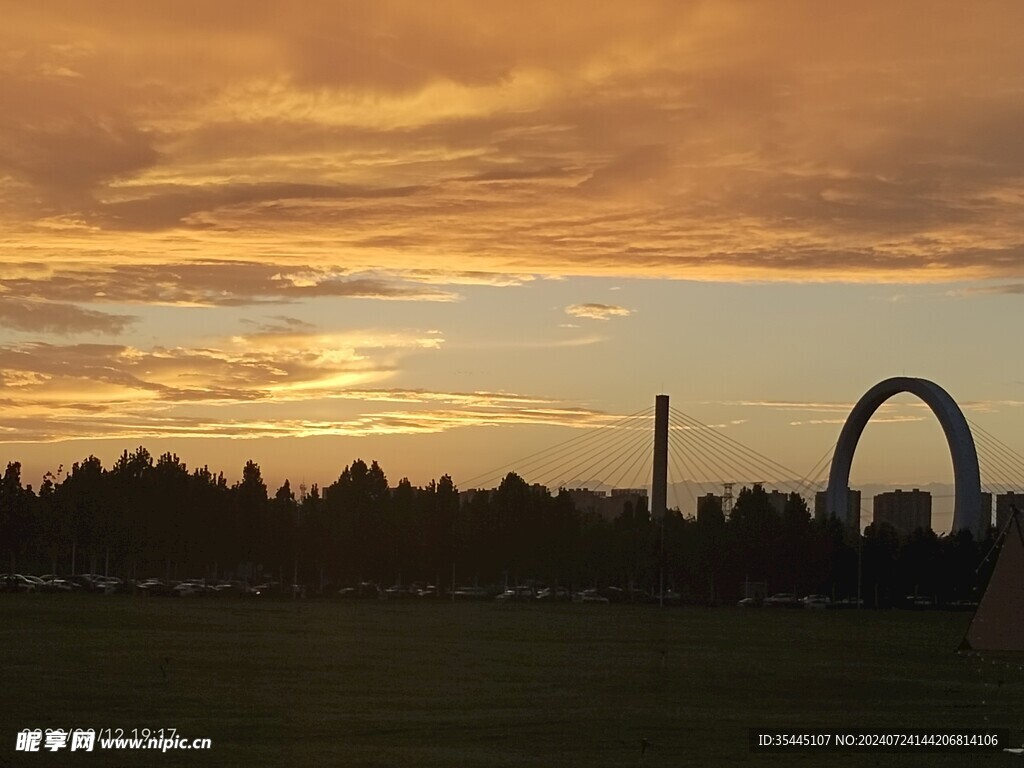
[0,331,609,442]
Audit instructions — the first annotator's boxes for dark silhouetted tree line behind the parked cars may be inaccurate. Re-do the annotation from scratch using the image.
[0,446,991,605]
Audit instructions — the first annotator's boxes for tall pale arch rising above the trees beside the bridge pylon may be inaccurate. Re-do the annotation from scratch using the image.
[825,376,990,539]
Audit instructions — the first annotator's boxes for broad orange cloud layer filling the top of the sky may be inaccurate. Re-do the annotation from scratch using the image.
[0,2,1024,301]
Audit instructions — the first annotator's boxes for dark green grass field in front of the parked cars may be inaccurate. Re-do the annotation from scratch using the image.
[0,595,1024,768]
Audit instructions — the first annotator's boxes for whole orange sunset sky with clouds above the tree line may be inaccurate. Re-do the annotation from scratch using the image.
[0,0,1024,524]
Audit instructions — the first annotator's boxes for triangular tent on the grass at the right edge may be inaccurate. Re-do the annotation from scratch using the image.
[961,508,1024,651]
